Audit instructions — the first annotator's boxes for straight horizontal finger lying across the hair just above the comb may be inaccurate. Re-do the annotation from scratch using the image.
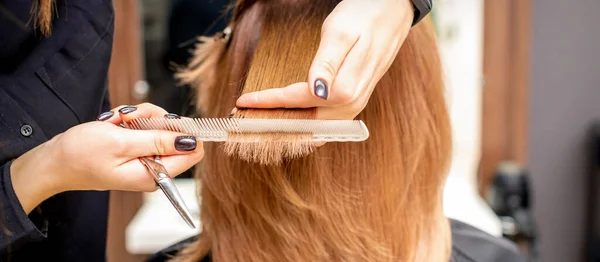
[236,82,327,108]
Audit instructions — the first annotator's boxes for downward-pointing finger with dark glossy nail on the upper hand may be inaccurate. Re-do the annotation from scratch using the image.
[308,19,359,100]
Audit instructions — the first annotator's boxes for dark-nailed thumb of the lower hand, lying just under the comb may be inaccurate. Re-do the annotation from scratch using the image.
[122,129,202,157]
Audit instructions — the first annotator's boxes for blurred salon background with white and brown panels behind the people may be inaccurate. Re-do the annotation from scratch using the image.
[108,0,600,262]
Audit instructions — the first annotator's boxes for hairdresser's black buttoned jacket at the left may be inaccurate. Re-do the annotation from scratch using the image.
[0,0,114,261]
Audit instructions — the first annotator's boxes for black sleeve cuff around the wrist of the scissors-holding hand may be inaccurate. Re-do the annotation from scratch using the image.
[0,161,48,261]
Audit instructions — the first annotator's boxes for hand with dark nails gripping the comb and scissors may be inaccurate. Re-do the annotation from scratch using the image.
[10,104,204,214]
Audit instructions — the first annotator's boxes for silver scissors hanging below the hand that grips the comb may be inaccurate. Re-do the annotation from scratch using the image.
[139,156,196,228]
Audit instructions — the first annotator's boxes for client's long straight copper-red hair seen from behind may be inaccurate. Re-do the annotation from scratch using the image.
[173,0,451,261]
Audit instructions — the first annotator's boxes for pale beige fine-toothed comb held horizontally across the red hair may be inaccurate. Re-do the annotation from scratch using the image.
[127,118,369,142]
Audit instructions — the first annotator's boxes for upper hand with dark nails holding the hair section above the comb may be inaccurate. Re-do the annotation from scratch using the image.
[236,0,414,119]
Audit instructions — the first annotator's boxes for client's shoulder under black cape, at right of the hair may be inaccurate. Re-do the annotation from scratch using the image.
[450,219,526,262]
